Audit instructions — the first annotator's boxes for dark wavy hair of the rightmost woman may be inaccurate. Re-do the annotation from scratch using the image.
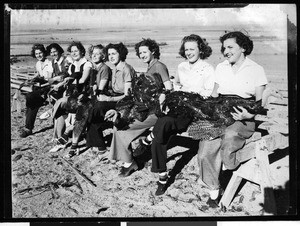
[220,31,253,56]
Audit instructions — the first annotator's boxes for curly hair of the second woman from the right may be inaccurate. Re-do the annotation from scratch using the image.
[179,34,212,60]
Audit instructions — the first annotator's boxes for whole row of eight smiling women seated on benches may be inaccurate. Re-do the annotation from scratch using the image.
[20,31,267,207]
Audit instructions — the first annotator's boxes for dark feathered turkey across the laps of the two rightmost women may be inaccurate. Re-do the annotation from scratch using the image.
[163,91,266,140]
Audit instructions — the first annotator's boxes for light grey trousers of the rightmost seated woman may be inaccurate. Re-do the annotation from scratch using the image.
[198,121,255,190]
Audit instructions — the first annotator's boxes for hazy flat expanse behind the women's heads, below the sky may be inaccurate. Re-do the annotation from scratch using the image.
[10,26,287,78]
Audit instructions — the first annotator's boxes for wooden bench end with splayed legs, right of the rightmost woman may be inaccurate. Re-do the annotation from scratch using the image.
[220,96,289,214]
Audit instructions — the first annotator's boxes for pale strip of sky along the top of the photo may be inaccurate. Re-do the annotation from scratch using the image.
[6,4,296,33]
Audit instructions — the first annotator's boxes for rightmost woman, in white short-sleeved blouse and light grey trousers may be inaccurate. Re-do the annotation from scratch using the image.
[198,31,268,207]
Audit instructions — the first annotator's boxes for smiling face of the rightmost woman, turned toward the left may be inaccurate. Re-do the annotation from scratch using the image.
[223,38,245,64]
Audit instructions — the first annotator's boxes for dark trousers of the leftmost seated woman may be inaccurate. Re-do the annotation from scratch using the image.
[25,91,45,130]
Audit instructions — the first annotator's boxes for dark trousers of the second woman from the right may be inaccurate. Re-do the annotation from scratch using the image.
[151,116,191,173]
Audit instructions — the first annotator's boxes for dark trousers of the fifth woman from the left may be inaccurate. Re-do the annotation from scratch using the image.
[86,101,117,149]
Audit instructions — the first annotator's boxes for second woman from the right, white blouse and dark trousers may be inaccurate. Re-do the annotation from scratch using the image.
[129,34,214,195]
